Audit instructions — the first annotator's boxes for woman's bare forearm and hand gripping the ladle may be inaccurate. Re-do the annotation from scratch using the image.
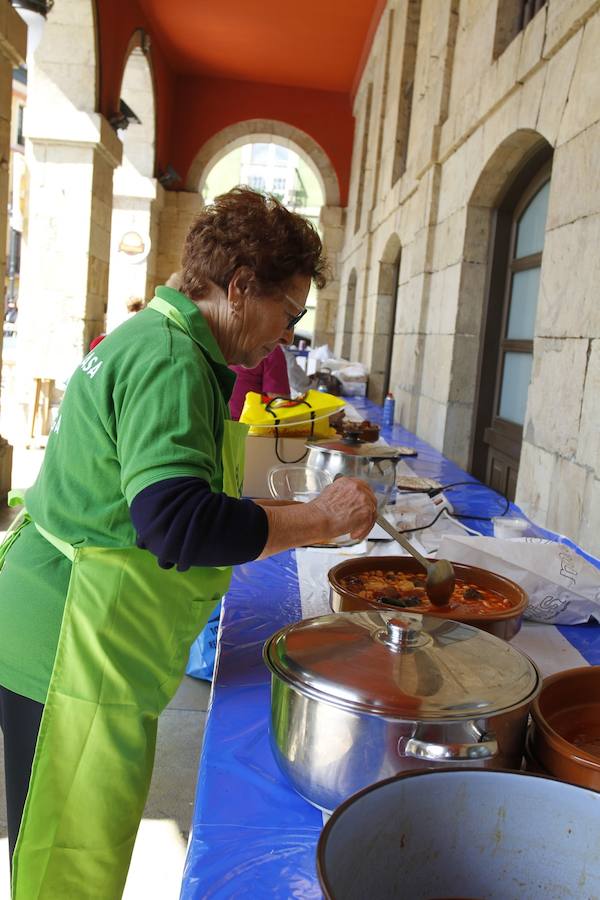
[257,477,377,559]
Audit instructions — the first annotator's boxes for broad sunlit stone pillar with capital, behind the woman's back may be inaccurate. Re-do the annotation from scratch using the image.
[17,110,122,415]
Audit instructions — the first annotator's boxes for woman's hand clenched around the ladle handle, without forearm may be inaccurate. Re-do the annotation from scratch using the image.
[308,477,377,542]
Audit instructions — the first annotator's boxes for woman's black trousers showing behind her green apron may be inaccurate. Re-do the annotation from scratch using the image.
[0,686,44,865]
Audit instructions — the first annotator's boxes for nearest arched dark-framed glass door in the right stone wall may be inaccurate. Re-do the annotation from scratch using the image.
[473,161,551,500]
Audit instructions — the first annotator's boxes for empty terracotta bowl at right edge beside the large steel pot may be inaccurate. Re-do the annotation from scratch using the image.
[531,666,600,791]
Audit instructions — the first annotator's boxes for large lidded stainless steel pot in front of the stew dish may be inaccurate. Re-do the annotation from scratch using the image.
[263,612,541,811]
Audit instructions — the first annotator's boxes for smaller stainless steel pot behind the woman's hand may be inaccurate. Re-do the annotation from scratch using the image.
[306,439,404,507]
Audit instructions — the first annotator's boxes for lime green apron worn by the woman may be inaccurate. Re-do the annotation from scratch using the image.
[7,298,247,900]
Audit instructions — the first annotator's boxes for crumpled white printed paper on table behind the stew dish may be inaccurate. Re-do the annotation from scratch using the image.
[438,535,600,625]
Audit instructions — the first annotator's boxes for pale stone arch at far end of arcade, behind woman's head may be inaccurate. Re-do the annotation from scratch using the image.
[186,119,344,347]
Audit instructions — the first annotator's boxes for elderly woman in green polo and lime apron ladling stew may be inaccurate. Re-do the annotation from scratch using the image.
[0,188,376,900]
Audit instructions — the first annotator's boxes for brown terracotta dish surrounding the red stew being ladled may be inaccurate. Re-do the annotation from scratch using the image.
[328,556,528,641]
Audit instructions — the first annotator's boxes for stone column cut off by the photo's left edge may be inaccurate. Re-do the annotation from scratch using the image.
[0,0,27,501]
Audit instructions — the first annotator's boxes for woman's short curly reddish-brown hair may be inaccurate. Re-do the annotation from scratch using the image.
[180,185,327,300]
